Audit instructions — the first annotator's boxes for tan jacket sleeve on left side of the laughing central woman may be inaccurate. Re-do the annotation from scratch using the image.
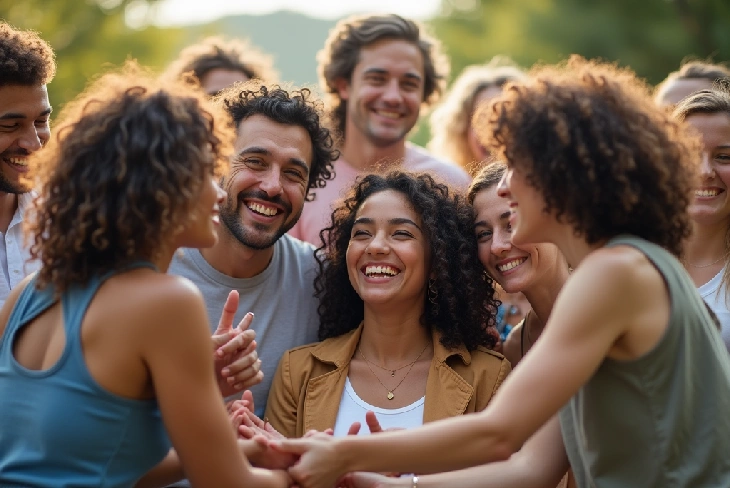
[264,351,299,438]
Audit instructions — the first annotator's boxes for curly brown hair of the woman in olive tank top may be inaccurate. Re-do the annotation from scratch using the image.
[475,56,700,255]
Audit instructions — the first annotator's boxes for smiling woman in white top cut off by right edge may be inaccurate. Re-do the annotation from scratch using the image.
[674,85,730,351]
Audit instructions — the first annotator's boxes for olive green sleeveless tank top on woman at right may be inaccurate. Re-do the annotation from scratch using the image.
[560,236,730,488]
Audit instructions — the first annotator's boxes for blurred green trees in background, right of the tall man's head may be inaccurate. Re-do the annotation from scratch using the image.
[431,0,730,83]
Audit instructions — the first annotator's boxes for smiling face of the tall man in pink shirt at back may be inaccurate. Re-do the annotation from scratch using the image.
[338,39,424,147]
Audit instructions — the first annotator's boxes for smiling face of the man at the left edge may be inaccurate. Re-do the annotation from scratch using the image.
[0,85,51,193]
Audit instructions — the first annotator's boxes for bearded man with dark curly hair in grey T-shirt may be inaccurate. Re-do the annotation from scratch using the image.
[170,81,337,434]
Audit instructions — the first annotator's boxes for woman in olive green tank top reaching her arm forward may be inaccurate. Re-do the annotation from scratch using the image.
[274,58,730,488]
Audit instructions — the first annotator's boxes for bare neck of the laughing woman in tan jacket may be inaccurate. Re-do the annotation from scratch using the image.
[358,306,433,368]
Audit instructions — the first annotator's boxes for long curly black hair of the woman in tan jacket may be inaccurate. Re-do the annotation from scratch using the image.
[314,171,499,350]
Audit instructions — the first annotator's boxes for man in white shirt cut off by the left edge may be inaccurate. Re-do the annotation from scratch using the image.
[0,22,56,305]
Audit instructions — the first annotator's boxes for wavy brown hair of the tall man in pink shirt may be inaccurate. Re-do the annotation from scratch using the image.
[317,14,450,137]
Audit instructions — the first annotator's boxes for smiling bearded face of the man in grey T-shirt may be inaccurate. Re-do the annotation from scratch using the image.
[221,115,313,249]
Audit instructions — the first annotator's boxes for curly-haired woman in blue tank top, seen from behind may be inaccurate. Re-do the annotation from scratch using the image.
[0,65,289,488]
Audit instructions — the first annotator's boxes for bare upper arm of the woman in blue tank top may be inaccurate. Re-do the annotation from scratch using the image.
[140,278,252,487]
